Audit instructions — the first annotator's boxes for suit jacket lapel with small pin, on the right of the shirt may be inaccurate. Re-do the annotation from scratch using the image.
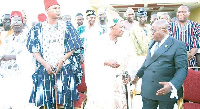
[146,36,173,67]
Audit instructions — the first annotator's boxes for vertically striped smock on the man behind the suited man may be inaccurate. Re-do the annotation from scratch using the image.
[169,20,200,67]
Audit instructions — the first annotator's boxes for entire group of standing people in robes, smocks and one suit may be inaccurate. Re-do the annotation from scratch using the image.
[0,0,200,109]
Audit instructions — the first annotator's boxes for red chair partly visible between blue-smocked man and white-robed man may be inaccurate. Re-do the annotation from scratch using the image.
[74,64,87,109]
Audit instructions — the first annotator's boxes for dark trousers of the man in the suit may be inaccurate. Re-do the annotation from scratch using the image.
[142,97,177,109]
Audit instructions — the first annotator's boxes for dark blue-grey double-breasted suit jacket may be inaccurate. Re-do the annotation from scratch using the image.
[137,36,188,101]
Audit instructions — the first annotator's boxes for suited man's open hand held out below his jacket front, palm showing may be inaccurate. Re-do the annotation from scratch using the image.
[156,82,172,95]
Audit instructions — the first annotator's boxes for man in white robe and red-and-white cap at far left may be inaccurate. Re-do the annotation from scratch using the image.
[0,11,34,109]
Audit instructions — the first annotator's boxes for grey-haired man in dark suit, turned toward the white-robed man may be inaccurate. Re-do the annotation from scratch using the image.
[132,19,188,109]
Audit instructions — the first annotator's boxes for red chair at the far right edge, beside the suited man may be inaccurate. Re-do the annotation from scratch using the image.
[180,69,200,109]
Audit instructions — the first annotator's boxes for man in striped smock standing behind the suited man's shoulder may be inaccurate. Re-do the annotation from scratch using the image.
[169,5,200,67]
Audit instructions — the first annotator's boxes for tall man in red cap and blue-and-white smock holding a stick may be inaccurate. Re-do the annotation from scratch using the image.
[27,0,82,109]
